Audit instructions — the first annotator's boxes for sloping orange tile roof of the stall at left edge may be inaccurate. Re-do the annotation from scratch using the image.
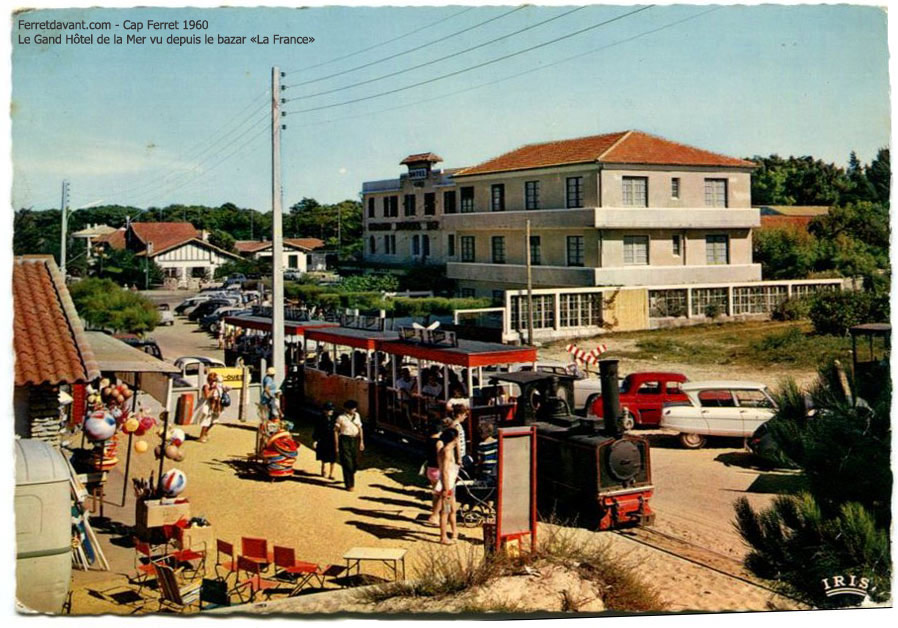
[12,255,100,386]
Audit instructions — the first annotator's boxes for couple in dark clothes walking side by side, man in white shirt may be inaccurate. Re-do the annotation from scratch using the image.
[312,399,365,491]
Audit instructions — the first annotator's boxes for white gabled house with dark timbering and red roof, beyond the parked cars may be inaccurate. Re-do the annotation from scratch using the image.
[94,222,240,285]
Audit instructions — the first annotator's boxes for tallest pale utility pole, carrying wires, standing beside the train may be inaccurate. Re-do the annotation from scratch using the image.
[271,66,287,385]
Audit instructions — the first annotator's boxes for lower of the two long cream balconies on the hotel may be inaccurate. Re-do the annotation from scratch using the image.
[446,262,761,288]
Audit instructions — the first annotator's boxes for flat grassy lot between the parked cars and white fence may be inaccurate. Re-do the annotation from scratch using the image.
[608,323,851,369]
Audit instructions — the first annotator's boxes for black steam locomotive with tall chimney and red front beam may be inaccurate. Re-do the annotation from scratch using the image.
[492,360,654,530]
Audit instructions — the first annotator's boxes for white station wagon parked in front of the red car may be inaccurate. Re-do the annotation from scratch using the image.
[661,381,776,449]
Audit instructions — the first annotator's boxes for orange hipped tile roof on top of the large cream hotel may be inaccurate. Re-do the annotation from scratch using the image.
[456,131,755,176]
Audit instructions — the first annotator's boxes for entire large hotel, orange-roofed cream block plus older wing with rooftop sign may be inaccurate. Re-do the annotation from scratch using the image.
[362,131,761,300]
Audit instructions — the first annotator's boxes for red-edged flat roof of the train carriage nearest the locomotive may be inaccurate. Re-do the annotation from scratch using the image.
[378,339,536,367]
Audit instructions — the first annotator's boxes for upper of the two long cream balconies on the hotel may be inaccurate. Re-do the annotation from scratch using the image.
[443,207,761,231]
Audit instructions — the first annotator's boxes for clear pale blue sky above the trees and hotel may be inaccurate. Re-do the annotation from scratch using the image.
[12,5,890,211]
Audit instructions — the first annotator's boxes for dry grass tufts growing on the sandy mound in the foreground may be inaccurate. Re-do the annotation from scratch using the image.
[359,524,665,613]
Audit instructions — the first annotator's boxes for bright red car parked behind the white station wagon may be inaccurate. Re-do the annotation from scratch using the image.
[591,371,689,429]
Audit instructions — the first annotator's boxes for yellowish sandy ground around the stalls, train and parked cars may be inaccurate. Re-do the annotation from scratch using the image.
[65,293,813,613]
